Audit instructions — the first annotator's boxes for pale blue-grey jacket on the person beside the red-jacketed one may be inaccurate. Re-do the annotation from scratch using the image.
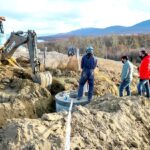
[121,60,133,81]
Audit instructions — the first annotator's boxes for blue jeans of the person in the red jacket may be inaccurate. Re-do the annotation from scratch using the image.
[137,79,150,98]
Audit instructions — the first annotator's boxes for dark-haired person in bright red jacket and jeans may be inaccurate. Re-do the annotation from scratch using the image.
[137,50,150,98]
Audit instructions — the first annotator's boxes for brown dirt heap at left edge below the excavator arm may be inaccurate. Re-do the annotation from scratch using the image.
[0,66,52,127]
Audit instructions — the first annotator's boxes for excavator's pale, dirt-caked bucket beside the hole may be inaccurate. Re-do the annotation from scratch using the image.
[32,71,52,88]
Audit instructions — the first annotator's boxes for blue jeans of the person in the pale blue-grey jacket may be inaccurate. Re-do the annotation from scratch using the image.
[119,80,131,97]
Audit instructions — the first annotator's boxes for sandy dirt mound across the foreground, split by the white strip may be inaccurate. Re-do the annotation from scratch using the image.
[0,95,150,150]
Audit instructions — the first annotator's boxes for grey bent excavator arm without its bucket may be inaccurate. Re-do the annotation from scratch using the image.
[1,30,40,74]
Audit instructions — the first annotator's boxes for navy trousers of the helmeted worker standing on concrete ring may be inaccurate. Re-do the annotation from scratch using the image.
[78,71,94,101]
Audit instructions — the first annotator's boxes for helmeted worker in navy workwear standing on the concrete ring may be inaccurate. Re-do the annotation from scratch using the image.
[77,46,97,102]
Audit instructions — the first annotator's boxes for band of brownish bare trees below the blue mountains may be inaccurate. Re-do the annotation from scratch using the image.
[38,34,150,61]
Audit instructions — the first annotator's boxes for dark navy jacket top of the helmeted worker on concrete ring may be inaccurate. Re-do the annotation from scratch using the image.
[81,54,97,71]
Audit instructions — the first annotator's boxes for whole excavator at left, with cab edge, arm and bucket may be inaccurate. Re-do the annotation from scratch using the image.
[0,17,52,87]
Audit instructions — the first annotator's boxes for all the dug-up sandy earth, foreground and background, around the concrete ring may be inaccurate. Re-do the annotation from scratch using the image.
[0,52,150,150]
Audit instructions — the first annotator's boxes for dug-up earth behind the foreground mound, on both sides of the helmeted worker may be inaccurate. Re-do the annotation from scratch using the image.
[0,50,137,127]
